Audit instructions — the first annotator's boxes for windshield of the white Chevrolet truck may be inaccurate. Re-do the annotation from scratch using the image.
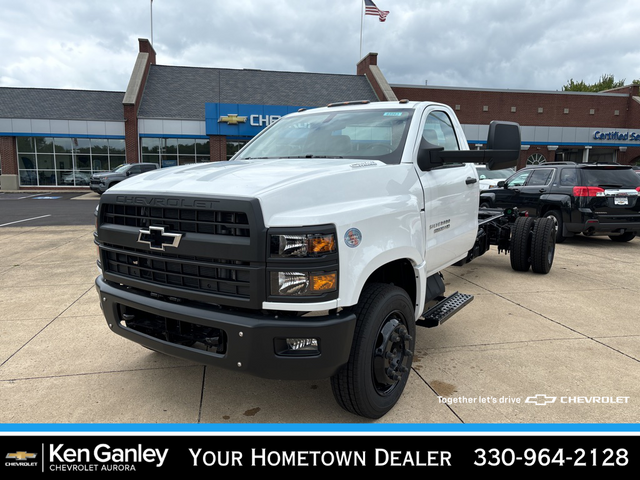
[233,107,413,163]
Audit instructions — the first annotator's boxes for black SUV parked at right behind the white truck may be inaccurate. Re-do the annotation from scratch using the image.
[480,162,640,242]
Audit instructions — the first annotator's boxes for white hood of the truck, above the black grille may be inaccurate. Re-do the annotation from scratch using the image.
[109,158,417,225]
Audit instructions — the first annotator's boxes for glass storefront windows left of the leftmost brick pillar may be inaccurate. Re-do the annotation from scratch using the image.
[16,137,126,187]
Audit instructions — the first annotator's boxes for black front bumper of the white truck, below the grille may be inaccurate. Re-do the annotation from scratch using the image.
[96,276,356,380]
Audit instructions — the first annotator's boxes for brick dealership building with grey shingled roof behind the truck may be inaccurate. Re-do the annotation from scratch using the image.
[0,39,640,191]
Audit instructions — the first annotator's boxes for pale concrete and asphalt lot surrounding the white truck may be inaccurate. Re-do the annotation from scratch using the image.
[0,194,640,428]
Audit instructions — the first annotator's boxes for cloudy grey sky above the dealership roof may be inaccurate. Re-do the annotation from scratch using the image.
[0,0,640,91]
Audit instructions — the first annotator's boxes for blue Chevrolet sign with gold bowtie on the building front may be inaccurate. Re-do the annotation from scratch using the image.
[204,103,306,137]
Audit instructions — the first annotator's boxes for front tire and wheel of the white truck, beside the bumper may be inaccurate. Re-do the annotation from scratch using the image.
[331,283,416,418]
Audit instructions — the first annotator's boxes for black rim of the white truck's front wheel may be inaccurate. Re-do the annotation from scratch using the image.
[373,310,413,395]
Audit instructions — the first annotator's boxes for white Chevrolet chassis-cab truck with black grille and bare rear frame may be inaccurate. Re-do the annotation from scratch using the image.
[95,101,555,418]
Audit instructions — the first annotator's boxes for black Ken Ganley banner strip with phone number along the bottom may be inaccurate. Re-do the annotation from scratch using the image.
[0,432,640,478]
